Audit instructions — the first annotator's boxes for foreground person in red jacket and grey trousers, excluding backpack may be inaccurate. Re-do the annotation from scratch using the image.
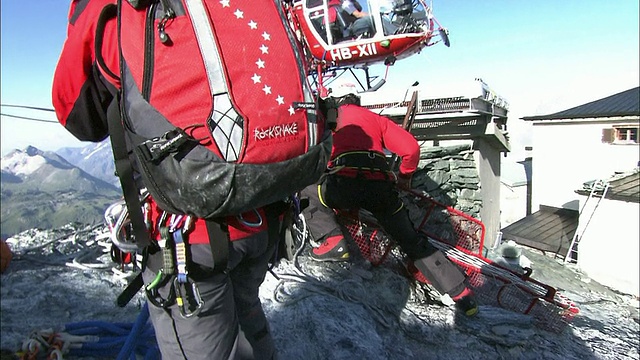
[52,0,276,360]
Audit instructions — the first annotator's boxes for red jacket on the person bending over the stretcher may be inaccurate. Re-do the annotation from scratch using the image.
[331,104,420,176]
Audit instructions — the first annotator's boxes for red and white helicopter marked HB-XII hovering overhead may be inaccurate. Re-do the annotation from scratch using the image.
[287,0,450,90]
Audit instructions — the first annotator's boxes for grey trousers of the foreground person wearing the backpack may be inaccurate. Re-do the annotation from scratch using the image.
[143,231,275,360]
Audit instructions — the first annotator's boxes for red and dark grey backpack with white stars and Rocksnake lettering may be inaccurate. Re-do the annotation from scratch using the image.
[102,0,331,219]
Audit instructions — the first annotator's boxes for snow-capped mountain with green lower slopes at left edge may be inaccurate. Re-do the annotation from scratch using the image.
[0,146,121,237]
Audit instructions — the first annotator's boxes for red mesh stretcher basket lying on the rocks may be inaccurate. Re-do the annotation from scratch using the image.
[338,190,579,333]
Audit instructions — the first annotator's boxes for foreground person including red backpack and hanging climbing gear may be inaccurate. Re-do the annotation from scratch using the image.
[53,0,332,359]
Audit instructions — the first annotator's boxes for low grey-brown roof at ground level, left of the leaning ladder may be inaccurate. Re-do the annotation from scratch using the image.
[501,205,578,258]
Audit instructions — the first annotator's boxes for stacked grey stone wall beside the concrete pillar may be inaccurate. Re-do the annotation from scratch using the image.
[412,144,482,219]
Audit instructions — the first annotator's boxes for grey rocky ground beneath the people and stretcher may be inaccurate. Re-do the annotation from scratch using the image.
[0,227,640,360]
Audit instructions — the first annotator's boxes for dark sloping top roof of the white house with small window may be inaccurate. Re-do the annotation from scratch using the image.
[522,87,640,121]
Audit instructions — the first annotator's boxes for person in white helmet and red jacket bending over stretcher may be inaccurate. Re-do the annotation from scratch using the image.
[307,83,478,316]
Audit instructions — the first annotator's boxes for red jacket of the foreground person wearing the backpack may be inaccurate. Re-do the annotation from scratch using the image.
[52,0,266,244]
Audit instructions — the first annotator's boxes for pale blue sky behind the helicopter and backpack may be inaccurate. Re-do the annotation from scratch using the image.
[0,0,640,155]
